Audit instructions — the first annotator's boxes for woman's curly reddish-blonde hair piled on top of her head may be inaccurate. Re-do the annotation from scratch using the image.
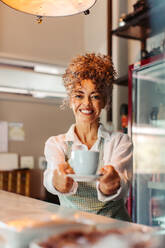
[63,53,116,108]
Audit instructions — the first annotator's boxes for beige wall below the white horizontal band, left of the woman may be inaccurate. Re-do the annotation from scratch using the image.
[0,93,74,168]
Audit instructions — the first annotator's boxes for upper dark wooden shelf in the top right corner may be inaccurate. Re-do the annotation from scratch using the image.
[112,3,165,41]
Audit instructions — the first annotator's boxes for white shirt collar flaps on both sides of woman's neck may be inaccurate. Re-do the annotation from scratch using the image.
[65,124,110,144]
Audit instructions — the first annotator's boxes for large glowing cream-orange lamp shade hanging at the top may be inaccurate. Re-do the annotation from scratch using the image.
[0,0,96,17]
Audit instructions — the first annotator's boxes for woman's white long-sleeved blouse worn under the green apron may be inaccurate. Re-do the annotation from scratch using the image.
[44,124,133,202]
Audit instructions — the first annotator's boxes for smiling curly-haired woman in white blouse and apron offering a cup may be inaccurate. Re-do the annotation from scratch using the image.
[44,54,132,221]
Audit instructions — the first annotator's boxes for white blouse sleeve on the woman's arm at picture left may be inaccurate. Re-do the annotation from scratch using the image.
[43,137,78,195]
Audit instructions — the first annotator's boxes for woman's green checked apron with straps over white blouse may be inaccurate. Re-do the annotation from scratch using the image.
[58,138,131,221]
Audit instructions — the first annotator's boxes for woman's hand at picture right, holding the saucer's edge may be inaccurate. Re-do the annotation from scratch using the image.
[99,165,120,196]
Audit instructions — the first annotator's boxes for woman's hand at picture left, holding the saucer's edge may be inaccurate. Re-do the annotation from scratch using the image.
[53,163,74,193]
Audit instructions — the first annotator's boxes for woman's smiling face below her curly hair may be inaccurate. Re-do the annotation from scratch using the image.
[70,79,105,124]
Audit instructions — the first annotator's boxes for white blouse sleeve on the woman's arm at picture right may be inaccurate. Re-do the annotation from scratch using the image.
[96,133,133,202]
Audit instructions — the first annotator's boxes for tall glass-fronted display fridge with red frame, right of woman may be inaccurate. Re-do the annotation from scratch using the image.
[128,54,165,228]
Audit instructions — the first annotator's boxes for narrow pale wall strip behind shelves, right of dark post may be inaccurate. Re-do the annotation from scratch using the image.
[112,0,128,131]
